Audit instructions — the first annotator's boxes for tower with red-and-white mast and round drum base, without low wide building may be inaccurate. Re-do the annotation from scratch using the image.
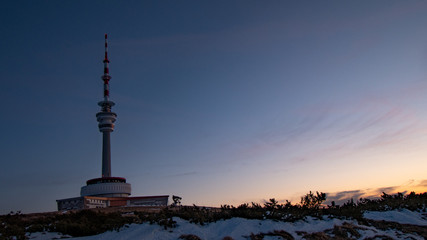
[80,34,131,197]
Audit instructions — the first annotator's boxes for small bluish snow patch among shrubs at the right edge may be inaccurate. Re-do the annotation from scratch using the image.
[363,209,427,226]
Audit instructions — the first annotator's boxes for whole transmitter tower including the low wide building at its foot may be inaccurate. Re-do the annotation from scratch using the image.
[56,34,171,211]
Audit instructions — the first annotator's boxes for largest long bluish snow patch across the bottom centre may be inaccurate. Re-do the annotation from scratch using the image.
[25,218,348,240]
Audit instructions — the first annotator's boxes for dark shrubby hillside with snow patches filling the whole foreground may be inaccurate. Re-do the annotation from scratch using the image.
[0,192,427,240]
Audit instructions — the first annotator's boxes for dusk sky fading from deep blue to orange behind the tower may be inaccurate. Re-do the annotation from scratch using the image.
[0,0,427,214]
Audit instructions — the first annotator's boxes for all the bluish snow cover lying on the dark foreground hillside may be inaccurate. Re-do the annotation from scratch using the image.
[29,210,427,240]
